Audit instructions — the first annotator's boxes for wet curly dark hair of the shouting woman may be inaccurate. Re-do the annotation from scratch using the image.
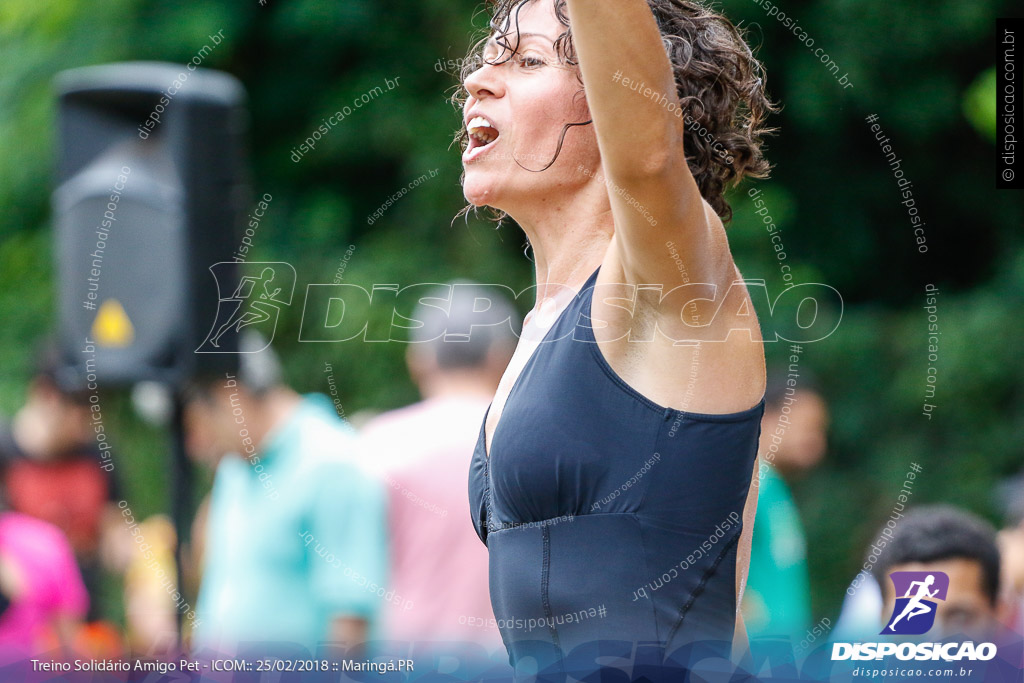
[453,0,777,221]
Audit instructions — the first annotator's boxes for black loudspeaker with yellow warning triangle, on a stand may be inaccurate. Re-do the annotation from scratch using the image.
[53,62,251,387]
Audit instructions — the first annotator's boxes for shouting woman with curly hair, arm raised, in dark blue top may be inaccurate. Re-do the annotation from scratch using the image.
[461,0,772,667]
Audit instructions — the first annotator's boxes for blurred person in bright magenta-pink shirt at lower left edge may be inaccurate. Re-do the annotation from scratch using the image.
[0,512,89,656]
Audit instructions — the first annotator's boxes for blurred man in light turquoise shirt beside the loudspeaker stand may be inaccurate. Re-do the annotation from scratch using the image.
[186,334,387,653]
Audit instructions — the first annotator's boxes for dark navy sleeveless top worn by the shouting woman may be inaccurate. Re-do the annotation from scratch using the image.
[469,271,764,666]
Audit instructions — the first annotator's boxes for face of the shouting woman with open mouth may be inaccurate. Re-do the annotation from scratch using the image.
[462,0,600,214]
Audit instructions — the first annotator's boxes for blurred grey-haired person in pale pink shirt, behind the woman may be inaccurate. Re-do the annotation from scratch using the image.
[360,283,518,650]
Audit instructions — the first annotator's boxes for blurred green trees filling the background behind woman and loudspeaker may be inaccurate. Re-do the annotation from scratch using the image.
[0,0,1024,618]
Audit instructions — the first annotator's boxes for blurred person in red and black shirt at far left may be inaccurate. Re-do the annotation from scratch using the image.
[0,346,118,620]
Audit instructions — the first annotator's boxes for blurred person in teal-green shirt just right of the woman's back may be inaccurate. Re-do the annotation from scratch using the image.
[743,371,828,641]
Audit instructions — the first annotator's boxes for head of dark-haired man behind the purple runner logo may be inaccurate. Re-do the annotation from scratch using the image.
[871,505,1000,637]
